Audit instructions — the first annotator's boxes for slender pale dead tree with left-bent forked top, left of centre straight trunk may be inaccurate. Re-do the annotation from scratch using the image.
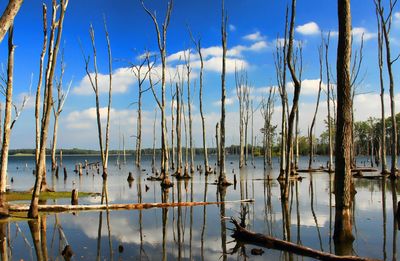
[189,30,211,174]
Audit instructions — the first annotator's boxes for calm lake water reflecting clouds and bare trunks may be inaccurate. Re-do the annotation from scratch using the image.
[3,153,400,260]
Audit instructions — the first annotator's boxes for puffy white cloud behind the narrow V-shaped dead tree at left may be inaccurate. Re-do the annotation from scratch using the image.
[72,68,135,95]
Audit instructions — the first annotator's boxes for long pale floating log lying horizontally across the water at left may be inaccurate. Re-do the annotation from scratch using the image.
[9,199,254,213]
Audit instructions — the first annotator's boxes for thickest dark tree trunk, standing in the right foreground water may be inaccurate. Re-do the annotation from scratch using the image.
[333,0,354,242]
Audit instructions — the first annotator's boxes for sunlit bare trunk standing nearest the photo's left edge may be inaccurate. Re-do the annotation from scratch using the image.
[0,25,15,193]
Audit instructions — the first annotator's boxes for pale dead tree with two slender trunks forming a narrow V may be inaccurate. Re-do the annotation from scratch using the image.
[82,18,112,180]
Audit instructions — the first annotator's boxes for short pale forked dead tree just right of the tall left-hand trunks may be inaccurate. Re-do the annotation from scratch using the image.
[51,49,72,170]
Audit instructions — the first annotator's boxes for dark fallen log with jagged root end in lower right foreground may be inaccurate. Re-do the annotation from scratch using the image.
[231,218,374,261]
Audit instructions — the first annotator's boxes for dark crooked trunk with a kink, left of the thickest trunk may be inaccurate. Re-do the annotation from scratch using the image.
[284,0,302,191]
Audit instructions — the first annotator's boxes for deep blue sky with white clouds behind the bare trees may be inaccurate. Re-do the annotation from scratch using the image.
[0,0,400,149]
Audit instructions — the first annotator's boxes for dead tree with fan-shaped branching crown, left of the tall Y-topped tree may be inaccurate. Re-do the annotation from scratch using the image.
[132,56,153,168]
